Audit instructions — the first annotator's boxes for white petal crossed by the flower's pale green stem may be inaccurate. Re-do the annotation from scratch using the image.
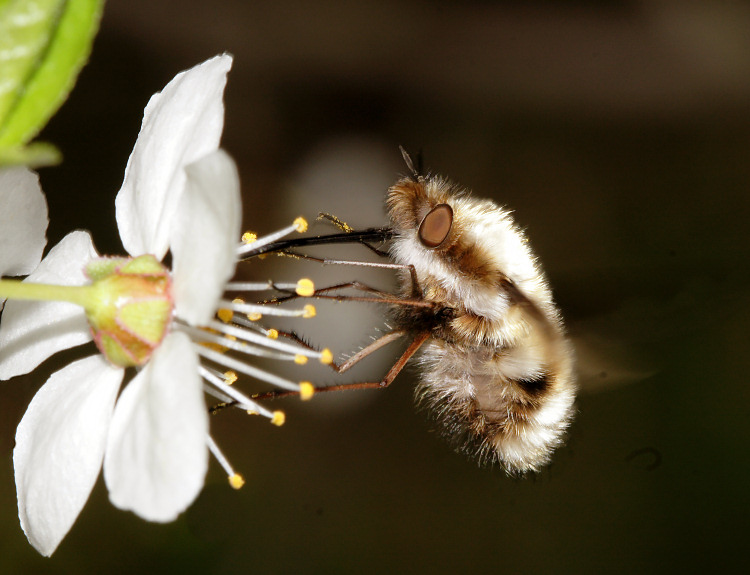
[0,232,98,380]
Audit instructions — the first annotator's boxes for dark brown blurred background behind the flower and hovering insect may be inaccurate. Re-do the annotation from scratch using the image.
[0,0,750,574]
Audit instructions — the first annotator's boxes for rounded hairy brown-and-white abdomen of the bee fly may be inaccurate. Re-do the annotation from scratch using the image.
[417,338,575,474]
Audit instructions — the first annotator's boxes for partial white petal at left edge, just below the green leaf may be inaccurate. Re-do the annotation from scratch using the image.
[0,168,49,276]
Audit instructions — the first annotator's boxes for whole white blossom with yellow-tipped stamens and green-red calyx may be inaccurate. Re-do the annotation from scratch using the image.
[0,55,332,555]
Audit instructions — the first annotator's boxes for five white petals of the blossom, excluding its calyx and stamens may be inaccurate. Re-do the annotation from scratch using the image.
[0,55,242,555]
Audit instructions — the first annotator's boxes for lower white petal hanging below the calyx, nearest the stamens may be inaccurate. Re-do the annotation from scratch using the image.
[104,333,208,522]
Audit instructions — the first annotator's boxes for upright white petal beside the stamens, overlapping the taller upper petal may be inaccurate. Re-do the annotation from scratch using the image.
[170,150,242,325]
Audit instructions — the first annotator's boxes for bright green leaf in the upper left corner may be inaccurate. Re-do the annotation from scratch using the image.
[0,0,104,162]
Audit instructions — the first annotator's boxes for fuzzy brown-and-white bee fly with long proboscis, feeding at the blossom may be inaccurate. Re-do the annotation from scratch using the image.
[247,149,576,474]
